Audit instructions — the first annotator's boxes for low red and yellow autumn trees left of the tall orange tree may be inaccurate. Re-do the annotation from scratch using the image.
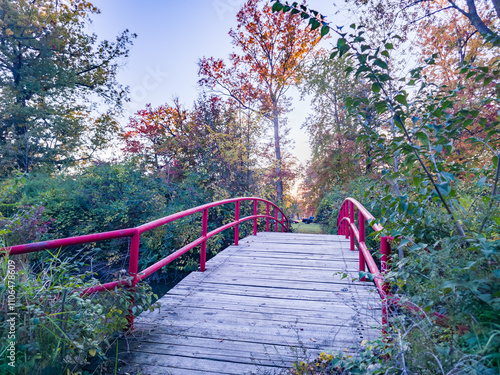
[122,95,261,197]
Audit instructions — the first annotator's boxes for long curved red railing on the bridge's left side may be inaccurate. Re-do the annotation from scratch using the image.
[0,197,290,329]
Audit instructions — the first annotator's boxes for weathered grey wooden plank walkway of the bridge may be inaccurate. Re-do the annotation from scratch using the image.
[119,232,381,375]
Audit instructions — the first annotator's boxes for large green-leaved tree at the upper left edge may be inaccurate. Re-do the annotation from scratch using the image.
[0,0,135,172]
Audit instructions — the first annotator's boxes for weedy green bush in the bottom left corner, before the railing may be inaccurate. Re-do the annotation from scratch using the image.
[0,254,153,375]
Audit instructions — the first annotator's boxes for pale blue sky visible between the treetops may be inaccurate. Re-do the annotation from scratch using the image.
[90,0,349,163]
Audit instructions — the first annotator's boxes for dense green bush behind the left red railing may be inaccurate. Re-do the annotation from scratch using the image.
[9,163,243,281]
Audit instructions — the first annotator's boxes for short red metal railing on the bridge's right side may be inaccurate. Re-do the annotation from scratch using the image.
[337,198,392,331]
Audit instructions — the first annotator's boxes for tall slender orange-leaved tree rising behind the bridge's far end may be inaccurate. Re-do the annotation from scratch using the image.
[199,0,321,201]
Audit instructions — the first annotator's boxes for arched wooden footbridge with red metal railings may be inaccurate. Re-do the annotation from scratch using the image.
[2,197,390,375]
